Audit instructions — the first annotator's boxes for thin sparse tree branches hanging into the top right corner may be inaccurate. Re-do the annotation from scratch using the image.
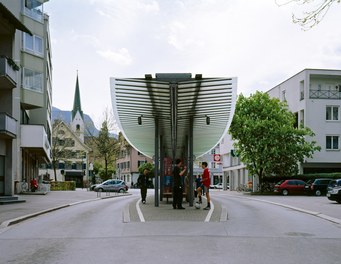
[275,0,341,29]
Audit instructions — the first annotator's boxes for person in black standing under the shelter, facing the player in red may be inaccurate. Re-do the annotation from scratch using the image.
[173,159,186,209]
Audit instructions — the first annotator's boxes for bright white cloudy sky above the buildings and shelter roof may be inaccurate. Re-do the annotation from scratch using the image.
[44,0,341,127]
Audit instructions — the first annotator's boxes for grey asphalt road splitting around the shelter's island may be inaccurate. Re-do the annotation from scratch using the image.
[0,191,341,264]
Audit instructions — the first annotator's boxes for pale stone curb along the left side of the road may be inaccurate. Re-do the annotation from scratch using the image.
[0,193,132,229]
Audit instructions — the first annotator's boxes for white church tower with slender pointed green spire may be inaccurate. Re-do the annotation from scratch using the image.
[71,73,85,143]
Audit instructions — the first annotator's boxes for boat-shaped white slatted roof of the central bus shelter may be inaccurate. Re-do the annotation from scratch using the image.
[111,73,237,158]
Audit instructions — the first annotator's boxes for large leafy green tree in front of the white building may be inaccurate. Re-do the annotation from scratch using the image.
[229,92,320,190]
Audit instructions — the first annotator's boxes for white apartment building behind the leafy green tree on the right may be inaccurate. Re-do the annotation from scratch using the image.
[221,69,341,190]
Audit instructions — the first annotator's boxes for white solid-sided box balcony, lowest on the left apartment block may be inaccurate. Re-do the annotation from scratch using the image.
[21,125,51,163]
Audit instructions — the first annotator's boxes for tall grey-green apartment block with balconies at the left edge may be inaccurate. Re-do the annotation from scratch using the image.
[0,0,52,196]
